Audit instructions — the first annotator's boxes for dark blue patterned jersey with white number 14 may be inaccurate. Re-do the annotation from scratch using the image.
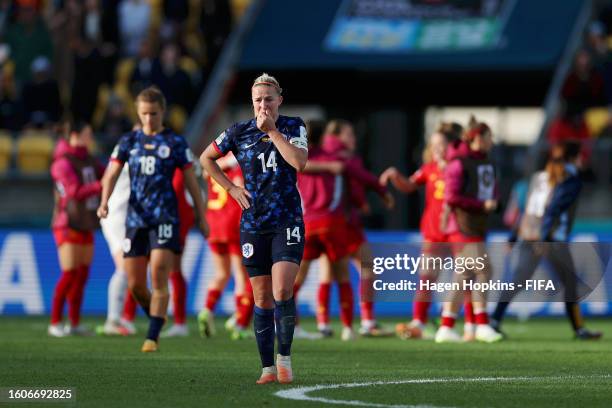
[213,116,307,233]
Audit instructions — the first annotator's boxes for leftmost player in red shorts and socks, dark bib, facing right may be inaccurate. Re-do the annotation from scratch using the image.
[48,123,104,337]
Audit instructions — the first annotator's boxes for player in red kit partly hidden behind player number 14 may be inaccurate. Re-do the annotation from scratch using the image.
[198,154,254,340]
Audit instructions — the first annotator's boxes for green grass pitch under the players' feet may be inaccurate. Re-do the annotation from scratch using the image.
[0,316,612,408]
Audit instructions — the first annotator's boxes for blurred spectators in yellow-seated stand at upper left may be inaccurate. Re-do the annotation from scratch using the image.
[0,0,249,177]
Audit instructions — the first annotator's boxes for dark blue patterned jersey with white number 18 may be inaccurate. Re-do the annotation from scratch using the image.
[111,129,193,228]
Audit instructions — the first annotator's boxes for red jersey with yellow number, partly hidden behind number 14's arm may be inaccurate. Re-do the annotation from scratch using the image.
[206,165,244,242]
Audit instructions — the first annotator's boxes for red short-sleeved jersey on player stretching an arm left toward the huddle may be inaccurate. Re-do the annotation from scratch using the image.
[410,161,446,242]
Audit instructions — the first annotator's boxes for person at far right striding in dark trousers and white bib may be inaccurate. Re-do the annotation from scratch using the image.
[491,142,602,340]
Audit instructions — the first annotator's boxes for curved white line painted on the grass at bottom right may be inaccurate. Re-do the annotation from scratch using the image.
[274,374,612,408]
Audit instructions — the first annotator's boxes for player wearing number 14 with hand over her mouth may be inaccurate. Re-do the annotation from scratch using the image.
[200,73,308,384]
